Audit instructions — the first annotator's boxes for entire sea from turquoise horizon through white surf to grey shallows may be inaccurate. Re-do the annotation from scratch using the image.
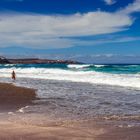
[0,64,140,125]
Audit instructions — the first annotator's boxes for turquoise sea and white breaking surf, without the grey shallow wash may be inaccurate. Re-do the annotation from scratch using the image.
[0,64,140,89]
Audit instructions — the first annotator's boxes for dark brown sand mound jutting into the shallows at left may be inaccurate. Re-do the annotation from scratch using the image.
[0,83,37,112]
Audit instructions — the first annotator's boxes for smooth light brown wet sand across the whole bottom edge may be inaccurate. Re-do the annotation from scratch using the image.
[0,121,140,140]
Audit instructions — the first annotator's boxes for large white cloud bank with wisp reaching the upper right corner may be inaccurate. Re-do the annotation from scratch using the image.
[0,0,140,48]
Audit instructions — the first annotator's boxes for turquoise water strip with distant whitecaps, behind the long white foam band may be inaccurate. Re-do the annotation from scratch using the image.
[0,64,140,74]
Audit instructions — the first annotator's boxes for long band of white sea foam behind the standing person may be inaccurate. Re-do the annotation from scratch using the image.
[0,68,140,89]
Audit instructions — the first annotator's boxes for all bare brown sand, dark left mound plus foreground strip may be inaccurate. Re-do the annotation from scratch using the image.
[0,83,140,140]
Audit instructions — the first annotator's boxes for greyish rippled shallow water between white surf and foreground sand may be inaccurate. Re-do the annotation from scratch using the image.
[0,78,140,120]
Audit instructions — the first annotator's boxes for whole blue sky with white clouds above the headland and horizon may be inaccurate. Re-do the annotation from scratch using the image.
[0,0,140,63]
